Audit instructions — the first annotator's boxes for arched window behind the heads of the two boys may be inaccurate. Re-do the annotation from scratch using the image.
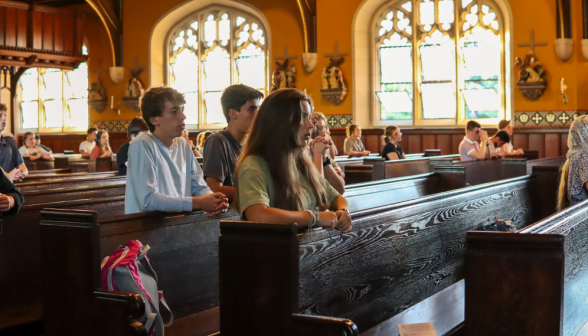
[167,6,269,128]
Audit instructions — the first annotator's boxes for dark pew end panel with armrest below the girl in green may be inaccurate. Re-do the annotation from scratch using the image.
[219,221,359,336]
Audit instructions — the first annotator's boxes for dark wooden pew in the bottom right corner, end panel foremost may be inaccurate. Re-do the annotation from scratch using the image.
[465,173,588,336]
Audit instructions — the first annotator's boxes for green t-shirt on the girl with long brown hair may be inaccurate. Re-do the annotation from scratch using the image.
[237,156,340,219]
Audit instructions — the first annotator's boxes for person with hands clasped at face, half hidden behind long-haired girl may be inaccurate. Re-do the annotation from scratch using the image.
[308,112,345,194]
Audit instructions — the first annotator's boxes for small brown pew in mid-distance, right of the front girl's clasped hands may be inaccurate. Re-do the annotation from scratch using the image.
[345,155,459,184]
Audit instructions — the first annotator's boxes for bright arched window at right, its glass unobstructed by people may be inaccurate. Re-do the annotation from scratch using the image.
[374,0,508,126]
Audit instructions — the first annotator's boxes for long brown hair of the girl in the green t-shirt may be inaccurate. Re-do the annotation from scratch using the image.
[234,89,329,211]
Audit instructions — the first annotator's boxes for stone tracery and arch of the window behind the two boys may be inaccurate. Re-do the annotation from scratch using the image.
[163,5,271,130]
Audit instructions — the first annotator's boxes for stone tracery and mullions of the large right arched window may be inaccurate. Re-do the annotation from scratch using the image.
[369,0,512,127]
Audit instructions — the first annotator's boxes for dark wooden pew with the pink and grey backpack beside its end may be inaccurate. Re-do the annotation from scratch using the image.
[40,209,239,336]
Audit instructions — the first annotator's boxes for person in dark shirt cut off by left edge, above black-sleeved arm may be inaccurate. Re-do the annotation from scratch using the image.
[0,104,29,182]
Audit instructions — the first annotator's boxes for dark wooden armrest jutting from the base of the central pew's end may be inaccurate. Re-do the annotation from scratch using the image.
[292,314,359,336]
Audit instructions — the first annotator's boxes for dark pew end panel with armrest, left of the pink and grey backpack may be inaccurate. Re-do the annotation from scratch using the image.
[40,209,146,336]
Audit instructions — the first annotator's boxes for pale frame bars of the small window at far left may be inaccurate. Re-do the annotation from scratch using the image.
[14,61,90,134]
